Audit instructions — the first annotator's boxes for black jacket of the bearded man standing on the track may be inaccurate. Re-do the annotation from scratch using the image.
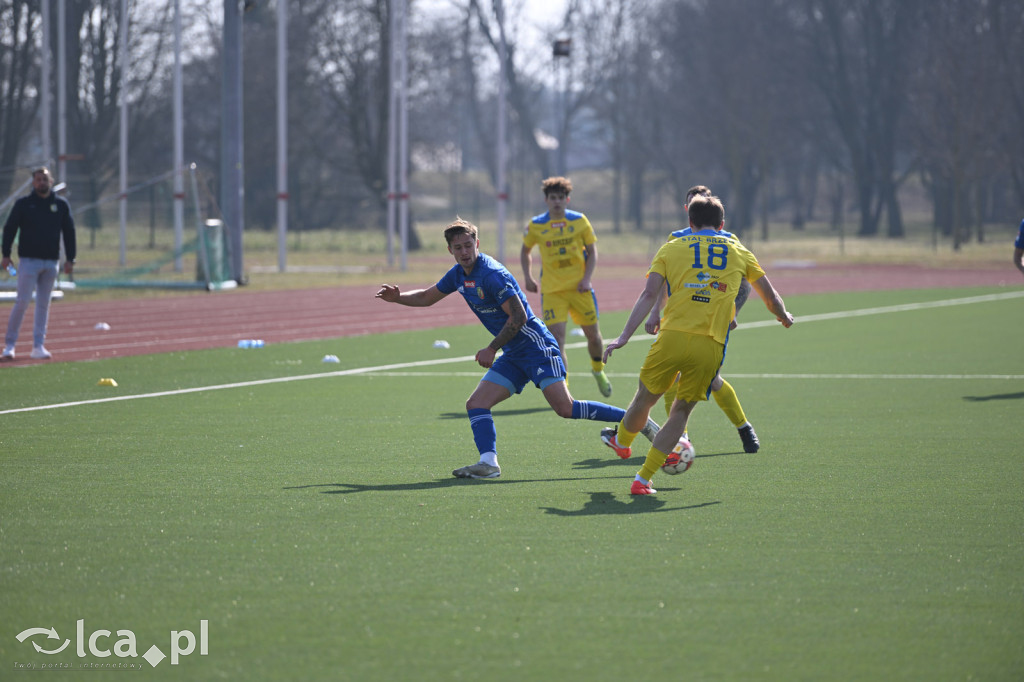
[0,191,77,260]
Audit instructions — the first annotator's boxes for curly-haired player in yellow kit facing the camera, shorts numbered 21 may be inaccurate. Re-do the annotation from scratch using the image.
[519,177,611,397]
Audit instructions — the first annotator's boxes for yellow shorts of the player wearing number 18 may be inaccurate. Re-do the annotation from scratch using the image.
[640,330,725,402]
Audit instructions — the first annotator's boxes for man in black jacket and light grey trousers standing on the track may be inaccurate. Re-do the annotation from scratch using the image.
[0,168,76,360]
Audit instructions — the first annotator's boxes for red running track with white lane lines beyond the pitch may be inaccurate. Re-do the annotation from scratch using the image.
[0,259,1022,367]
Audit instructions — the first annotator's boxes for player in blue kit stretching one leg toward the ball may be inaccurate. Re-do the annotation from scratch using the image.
[377,219,657,478]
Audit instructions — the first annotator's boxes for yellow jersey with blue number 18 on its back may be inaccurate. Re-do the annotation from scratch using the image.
[648,228,765,344]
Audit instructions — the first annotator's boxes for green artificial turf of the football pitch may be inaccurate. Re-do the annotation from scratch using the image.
[0,289,1024,682]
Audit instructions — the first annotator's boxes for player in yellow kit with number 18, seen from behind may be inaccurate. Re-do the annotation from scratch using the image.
[601,197,794,495]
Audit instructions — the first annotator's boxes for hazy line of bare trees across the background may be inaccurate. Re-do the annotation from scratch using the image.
[0,0,1024,248]
